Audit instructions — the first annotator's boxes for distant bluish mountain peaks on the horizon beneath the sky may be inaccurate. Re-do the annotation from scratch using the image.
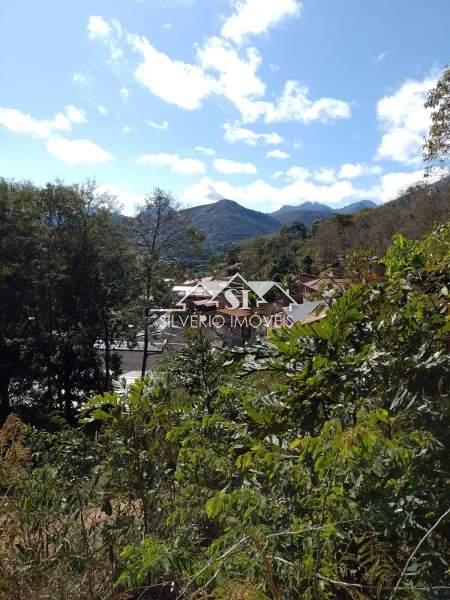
[185,199,377,254]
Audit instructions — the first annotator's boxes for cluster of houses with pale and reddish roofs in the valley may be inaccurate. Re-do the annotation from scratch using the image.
[113,273,348,382]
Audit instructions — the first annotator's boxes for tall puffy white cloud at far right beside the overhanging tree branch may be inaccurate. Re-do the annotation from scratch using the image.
[377,78,435,165]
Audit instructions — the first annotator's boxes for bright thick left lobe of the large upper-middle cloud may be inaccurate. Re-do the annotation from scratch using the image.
[128,35,215,110]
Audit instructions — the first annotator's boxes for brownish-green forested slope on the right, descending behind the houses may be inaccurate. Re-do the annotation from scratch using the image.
[216,178,450,279]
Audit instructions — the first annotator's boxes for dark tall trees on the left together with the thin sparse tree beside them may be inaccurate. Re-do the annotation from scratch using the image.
[0,179,198,422]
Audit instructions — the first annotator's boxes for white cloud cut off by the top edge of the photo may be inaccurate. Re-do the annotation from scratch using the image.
[221,0,302,44]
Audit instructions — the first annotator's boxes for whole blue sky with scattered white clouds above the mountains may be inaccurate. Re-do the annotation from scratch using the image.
[0,0,450,214]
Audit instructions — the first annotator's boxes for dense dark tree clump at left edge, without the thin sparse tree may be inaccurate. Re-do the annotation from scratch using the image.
[0,180,137,419]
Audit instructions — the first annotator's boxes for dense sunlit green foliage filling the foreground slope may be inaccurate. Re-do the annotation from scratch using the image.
[0,225,450,600]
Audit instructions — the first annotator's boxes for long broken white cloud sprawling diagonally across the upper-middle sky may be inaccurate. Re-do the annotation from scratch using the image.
[88,18,350,123]
